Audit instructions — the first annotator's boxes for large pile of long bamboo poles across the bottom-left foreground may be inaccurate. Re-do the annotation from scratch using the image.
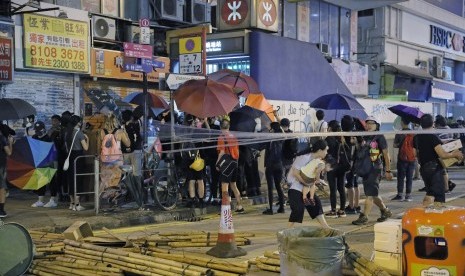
[29,231,253,276]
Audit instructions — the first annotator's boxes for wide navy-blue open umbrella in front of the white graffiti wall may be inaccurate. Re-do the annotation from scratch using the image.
[310,93,364,110]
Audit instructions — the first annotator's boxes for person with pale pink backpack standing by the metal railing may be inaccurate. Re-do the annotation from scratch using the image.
[97,113,131,196]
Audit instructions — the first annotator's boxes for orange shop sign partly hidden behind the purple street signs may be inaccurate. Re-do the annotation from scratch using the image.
[90,49,170,82]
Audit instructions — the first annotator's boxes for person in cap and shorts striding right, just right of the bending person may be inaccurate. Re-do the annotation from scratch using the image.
[352,116,392,225]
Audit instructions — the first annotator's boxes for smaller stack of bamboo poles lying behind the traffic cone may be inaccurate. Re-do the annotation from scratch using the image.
[131,231,254,248]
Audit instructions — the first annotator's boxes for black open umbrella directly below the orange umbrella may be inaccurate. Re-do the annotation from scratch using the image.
[229,105,271,132]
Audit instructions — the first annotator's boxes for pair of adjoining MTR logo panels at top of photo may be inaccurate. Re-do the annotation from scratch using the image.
[218,0,279,32]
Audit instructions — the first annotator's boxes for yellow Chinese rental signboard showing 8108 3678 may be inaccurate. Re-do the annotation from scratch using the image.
[23,14,89,73]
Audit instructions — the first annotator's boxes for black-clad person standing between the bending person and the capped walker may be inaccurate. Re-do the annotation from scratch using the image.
[326,120,350,218]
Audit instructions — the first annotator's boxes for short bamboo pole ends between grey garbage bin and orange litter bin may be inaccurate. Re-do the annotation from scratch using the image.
[343,251,391,276]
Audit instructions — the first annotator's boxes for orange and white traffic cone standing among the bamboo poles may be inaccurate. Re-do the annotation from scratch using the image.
[207,192,247,258]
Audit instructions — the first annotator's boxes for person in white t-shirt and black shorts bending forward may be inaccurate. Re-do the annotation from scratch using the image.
[287,140,330,228]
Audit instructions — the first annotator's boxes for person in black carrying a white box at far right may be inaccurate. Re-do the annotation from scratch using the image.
[414,114,463,207]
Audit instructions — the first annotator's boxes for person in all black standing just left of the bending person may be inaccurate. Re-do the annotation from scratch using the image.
[263,122,284,215]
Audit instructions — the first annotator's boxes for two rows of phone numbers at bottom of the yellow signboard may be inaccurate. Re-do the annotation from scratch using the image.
[29,45,87,71]
